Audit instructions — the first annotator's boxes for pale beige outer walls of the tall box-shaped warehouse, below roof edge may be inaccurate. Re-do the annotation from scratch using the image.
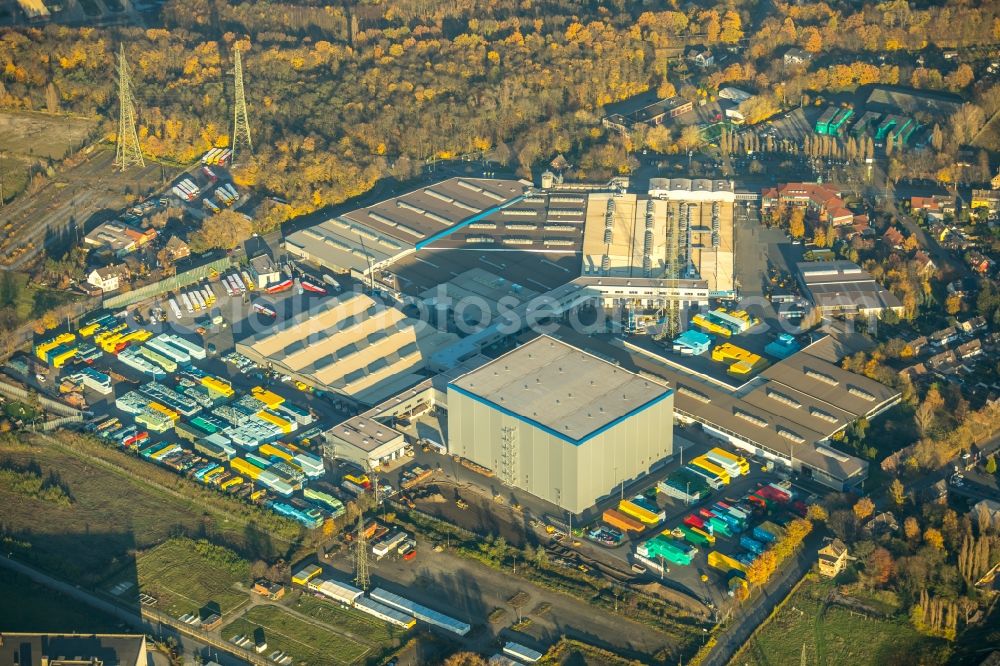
[448,390,674,513]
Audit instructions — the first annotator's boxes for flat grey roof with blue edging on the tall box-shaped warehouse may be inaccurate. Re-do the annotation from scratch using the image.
[449,335,672,444]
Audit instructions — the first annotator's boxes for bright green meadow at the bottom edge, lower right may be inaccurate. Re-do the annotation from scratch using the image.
[729,574,941,666]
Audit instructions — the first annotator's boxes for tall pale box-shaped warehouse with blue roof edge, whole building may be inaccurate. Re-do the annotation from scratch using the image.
[448,335,673,513]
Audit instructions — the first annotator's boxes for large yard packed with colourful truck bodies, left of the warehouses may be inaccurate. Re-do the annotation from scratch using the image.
[34,264,360,528]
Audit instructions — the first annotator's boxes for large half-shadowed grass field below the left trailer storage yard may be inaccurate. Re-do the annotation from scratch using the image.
[0,436,266,585]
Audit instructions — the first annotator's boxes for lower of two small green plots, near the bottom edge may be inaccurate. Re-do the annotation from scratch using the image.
[222,605,372,666]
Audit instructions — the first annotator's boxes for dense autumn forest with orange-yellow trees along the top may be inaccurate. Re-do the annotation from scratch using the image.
[0,0,1000,230]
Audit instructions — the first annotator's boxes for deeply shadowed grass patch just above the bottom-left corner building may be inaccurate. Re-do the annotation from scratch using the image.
[0,569,120,633]
